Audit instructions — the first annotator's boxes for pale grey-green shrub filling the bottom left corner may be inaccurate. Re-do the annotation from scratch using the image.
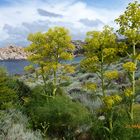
[0,110,43,140]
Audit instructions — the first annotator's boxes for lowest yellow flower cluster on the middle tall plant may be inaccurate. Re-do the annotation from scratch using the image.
[103,95,122,109]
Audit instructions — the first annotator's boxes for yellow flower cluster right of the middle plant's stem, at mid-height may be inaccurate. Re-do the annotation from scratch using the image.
[104,70,119,80]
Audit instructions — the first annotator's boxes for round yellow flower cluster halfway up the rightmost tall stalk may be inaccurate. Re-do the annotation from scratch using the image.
[123,62,137,72]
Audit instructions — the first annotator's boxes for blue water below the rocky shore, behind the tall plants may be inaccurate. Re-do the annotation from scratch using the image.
[0,57,83,75]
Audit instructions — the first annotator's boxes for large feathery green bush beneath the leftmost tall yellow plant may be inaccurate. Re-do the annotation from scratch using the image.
[26,87,90,138]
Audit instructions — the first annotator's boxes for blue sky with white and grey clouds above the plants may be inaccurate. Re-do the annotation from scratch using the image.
[0,0,136,47]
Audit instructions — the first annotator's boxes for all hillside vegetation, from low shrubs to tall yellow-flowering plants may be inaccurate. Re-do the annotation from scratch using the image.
[0,1,140,140]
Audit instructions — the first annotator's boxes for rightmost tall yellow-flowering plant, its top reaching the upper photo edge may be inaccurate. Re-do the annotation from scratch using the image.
[115,1,140,120]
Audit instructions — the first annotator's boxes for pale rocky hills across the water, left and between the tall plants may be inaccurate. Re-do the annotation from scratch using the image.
[0,40,84,60]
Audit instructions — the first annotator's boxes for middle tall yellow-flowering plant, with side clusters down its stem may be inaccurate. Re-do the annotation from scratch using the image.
[81,26,122,137]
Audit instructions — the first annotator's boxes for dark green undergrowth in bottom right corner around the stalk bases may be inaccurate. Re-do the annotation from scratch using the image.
[89,105,140,140]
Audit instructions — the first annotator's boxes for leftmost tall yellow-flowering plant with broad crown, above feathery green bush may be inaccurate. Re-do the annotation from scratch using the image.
[26,27,74,95]
